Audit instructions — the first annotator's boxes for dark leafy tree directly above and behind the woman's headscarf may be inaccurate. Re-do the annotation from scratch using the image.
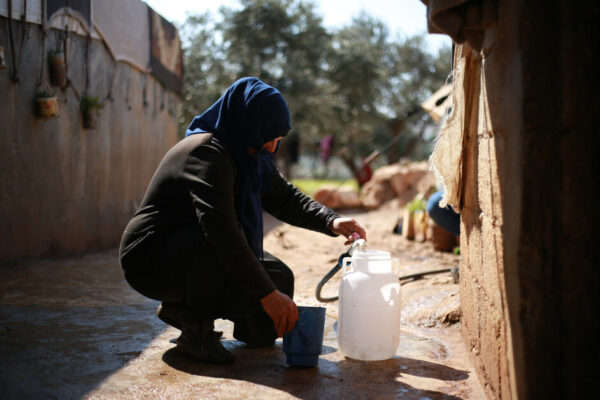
[220,0,330,137]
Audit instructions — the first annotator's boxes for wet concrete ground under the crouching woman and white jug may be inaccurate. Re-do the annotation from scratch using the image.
[0,214,484,399]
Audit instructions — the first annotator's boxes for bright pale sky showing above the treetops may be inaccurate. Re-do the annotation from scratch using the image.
[145,0,451,51]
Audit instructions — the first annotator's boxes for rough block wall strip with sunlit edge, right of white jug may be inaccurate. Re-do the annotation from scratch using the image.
[460,1,522,399]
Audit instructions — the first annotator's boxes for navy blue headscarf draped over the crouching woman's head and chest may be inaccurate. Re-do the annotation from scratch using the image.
[185,78,290,258]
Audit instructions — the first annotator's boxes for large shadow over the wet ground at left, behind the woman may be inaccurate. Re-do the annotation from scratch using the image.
[0,250,165,400]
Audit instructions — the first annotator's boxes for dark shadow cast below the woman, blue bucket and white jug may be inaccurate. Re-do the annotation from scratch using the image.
[162,340,469,399]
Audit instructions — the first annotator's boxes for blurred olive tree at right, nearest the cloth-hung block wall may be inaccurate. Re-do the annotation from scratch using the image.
[328,19,450,169]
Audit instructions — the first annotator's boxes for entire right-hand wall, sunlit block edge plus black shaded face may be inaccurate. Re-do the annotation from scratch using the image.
[461,0,600,399]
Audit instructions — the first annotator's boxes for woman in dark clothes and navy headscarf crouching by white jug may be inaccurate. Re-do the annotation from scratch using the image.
[120,78,366,364]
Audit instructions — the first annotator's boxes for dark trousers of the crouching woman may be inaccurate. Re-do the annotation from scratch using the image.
[121,225,294,342]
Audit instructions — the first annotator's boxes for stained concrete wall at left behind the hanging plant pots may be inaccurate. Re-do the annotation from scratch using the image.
[0,18,180,261]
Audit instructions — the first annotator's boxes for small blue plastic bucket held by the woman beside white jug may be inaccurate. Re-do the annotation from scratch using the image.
[283,306,325,367]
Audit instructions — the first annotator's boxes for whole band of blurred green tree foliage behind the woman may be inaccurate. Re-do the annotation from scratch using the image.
[180,0,451,169]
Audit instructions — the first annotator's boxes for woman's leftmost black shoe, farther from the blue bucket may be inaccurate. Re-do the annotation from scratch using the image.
[176,321,235,364]
